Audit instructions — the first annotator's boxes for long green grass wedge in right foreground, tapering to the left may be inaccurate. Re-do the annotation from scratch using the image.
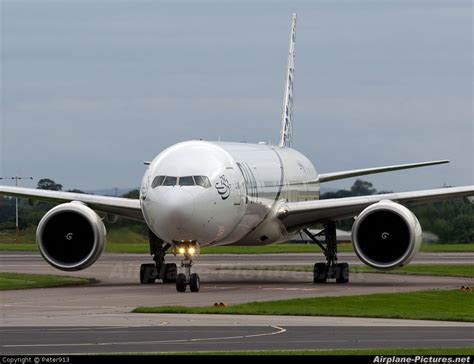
[133,290,474,322]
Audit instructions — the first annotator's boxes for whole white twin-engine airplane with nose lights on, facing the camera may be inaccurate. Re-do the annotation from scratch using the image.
[0,14,474,292]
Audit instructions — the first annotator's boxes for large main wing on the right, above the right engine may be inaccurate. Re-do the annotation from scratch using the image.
[278,185,474,231]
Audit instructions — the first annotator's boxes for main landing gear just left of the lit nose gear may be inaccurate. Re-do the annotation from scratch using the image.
[140,230,178,284]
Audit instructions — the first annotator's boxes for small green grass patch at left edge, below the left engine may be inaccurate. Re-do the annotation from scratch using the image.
[0,273,92,291]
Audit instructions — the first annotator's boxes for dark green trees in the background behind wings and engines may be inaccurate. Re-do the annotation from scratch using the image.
[0,178,474,243]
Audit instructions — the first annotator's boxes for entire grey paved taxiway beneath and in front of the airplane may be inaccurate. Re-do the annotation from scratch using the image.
[0,253,474,354]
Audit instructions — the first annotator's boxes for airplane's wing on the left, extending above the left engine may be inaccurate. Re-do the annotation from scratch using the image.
[0,186,143,221]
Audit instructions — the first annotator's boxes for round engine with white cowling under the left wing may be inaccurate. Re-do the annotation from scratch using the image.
[36,201,106,271]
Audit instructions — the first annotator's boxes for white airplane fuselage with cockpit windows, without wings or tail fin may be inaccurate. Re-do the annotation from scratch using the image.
[140,141,319,246]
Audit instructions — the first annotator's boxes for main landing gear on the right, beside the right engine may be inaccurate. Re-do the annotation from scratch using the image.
[303,221,349,283]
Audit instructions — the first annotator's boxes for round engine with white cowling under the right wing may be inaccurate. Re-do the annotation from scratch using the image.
[352,200,422,270]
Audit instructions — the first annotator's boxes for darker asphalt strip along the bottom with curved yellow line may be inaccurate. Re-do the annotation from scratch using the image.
[0,325,474,355]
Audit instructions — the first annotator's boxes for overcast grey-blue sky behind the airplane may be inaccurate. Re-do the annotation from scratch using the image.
[0,0,474,191]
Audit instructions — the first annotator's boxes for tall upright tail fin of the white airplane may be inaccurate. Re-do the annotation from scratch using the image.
[278,13,296,147]
